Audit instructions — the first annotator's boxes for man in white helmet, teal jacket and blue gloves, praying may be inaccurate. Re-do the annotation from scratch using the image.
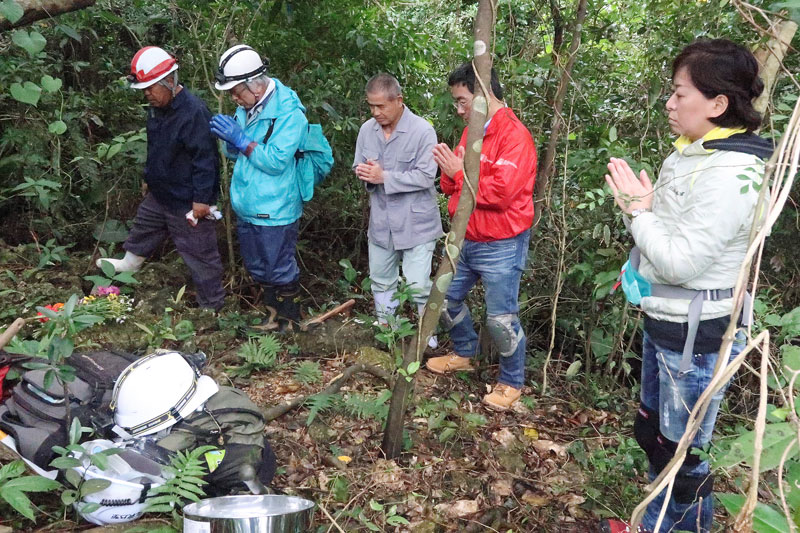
[211,45,308,331]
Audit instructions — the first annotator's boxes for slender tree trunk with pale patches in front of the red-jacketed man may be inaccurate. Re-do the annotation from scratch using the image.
[381,0,496,458]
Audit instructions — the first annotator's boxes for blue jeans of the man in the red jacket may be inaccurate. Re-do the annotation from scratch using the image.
[447,230,530,389]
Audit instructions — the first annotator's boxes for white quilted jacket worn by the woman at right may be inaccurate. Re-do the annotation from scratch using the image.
[631,128,764,322]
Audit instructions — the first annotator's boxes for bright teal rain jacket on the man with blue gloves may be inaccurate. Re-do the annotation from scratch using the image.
[223,78,308,226]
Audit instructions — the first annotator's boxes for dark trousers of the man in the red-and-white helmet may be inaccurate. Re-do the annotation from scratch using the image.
[122,194,225,309]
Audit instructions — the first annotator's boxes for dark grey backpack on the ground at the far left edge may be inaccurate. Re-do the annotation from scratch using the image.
[0,350,138,468]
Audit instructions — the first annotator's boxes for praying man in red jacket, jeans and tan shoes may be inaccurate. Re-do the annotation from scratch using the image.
[426,63,536,410]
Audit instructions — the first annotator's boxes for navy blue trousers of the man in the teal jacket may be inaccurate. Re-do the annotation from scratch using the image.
[236,220,300,287]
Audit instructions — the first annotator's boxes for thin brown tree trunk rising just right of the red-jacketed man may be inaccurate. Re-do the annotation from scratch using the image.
[533,0,587,229]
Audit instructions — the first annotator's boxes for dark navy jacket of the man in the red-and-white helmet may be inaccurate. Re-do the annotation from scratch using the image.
[144,88,219,214]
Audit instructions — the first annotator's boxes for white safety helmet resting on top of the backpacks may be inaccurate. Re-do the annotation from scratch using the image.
[110,352,219,438]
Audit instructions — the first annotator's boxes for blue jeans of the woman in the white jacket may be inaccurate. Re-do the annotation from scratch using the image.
[641,330,745,533]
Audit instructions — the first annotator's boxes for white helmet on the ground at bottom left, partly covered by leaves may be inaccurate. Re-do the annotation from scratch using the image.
[72,440,166,525]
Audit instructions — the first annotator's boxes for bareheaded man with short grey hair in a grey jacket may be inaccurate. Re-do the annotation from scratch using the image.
[353,73,442,330]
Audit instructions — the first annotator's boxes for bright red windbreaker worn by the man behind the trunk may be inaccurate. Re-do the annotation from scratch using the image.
[440,107,536,242]
